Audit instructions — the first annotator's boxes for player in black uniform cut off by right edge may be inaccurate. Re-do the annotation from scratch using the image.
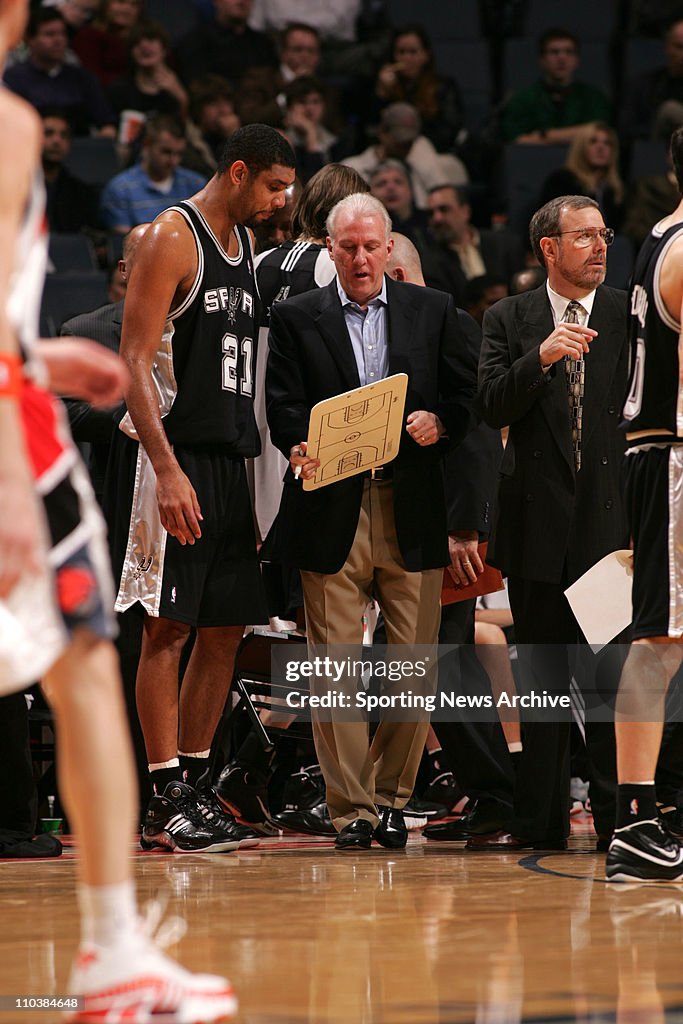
[606,128,683,882]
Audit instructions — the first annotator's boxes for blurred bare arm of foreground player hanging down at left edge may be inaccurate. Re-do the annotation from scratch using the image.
[0,97,41,598]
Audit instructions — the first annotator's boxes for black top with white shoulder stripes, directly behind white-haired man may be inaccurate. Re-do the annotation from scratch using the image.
[256,241,335,328]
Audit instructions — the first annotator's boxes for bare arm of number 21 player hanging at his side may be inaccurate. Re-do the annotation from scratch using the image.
[121,213,202,545]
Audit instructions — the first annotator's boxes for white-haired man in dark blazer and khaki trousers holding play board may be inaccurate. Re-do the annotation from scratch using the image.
[266,195,478,849]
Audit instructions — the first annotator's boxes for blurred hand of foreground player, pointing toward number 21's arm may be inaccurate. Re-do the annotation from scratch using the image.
[39,338,128,409]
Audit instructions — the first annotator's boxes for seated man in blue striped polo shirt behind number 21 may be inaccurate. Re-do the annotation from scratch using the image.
[100,115,206,234]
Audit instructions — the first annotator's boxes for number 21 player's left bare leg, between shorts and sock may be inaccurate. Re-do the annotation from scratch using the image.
[135,615,191,764]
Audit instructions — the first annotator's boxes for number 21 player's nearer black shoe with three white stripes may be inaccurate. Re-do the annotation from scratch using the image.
[140,782,241,853]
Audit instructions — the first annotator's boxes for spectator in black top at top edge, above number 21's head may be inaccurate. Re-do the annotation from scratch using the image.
[176,0,278,89]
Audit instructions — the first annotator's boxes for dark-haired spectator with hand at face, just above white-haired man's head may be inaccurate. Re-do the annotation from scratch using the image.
[285,78,340,184]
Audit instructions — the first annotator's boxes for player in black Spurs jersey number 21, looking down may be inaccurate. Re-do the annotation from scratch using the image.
[110,125,294,851]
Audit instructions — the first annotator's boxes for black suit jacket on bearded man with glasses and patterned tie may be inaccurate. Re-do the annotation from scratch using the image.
[479,285,629,584]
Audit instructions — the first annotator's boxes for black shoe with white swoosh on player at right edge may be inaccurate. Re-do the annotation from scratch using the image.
[605,818,683,882]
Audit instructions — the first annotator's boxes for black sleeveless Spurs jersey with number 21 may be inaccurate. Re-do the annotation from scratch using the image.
[121,200,260,458]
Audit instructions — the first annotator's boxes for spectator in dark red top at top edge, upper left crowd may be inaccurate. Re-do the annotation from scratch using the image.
[74,0,142,85]
